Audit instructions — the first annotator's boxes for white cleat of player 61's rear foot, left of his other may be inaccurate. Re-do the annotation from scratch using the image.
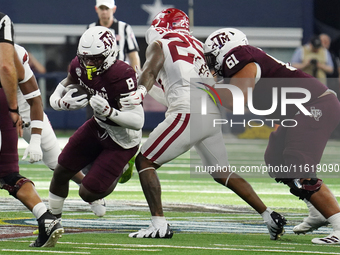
[293,202,329,235]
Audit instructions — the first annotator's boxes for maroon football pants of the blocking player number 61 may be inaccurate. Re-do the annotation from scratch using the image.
[264,94,340,179]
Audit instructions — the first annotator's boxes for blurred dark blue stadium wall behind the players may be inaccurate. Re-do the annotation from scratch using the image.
[0,0,340,133]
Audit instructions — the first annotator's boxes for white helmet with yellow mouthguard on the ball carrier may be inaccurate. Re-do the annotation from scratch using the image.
[77,26,118,80]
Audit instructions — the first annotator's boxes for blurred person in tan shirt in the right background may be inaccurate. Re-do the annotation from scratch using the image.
[291,35,333,85]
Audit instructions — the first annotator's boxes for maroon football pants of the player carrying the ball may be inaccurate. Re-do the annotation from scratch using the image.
[58,118,138,194]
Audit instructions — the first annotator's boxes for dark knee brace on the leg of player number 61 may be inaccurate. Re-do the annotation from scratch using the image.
[276,178,323,201]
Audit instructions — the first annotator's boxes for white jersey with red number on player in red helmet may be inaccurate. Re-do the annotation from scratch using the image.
[146,27,218,114]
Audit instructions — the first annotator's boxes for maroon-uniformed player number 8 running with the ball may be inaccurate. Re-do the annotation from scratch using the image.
[49,26,144,235]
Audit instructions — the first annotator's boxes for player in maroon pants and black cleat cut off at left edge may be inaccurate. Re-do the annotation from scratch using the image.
[0,12,64,247]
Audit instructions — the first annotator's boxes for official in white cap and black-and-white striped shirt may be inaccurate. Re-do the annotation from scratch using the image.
[89,0,140,70]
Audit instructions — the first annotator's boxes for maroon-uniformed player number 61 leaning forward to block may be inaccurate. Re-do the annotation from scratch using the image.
[204,28,340,244]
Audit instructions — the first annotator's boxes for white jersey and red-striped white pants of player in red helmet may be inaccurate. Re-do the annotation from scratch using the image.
[141,28,229,169]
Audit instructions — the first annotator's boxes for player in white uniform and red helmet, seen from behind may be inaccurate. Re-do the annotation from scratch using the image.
[120,8,286,240]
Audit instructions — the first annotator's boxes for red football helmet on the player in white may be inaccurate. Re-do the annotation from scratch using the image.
[151,8,190,32]
